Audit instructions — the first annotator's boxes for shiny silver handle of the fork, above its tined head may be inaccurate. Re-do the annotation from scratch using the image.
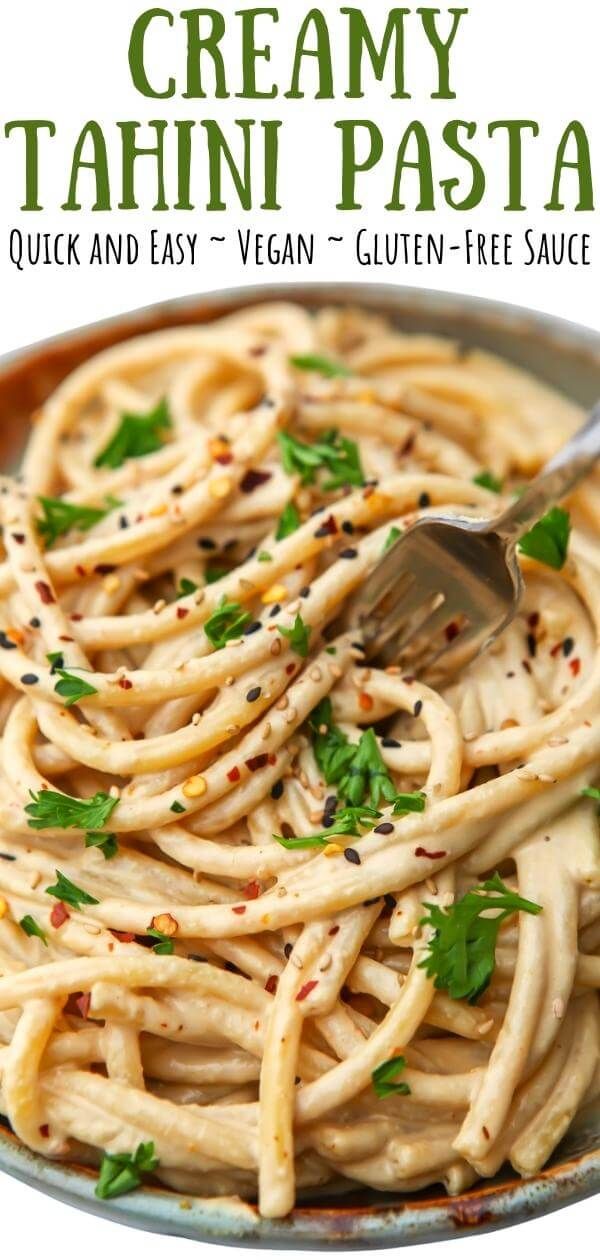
[493,402,600,543]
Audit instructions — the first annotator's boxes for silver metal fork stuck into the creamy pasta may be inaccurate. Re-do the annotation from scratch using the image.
[344,403,600,678]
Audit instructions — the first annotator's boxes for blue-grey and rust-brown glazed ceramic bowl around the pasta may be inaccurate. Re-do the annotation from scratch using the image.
[0,284,600,1250]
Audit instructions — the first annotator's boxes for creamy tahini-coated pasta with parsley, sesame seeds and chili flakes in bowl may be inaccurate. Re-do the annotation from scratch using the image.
[0,305,600,1217]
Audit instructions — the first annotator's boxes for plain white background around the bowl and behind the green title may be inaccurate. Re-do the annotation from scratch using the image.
[0,0,600,1260]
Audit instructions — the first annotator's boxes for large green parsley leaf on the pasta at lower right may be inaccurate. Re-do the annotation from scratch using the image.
[418,873,542,1003]
